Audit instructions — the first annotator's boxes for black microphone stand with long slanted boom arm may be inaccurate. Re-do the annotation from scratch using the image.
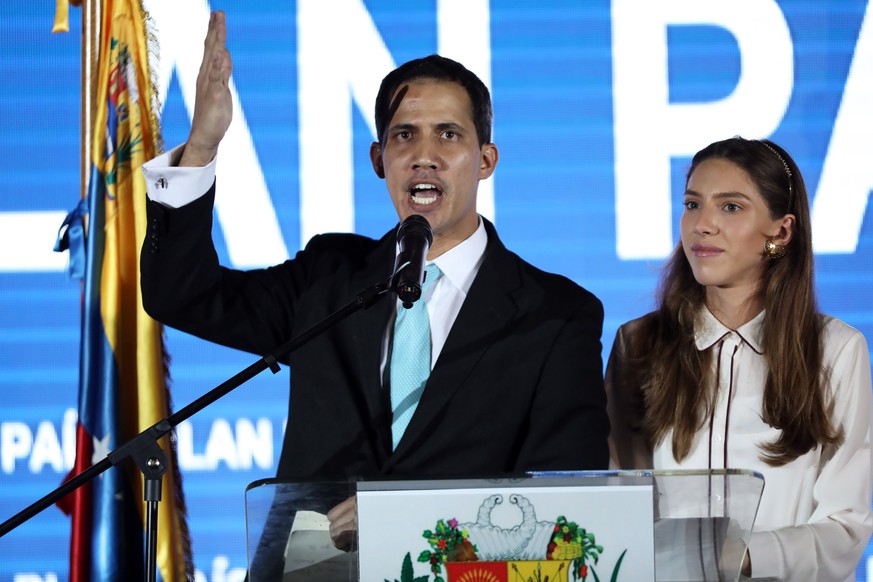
[0,276,396,582]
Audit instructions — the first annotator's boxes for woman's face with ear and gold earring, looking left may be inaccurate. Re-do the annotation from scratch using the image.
[680,158,793,296]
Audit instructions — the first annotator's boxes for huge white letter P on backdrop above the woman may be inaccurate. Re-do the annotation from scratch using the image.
[612,0,794,260]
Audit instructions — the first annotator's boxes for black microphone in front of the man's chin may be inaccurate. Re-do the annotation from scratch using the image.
[391,214,433,309]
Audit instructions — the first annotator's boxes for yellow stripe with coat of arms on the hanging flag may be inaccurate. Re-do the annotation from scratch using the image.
[91,0,193,582]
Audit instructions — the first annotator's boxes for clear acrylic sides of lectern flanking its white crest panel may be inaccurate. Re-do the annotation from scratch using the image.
[245,469,764,582]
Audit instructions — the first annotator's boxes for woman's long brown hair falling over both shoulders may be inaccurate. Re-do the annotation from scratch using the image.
[628,137,842,466]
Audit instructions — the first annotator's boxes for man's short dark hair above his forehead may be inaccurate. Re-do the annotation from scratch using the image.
[376,55,493,147]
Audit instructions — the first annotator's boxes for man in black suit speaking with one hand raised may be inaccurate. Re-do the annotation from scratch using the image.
[142,13,609,544]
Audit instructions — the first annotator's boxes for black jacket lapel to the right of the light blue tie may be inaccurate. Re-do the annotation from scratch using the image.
[389,221,520,464]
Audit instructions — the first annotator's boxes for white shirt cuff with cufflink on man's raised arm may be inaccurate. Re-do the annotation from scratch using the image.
[142,146,215,208]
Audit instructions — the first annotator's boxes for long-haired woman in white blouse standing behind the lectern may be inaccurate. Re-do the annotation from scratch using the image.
[606,137,873,582]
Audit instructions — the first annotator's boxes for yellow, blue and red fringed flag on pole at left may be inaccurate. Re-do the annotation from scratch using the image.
[52,0,193,582]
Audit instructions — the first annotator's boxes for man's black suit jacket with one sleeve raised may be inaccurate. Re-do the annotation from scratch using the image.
[141,187,609,479]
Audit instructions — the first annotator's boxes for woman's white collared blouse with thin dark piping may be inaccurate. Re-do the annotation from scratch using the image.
[653,310,873,582]
